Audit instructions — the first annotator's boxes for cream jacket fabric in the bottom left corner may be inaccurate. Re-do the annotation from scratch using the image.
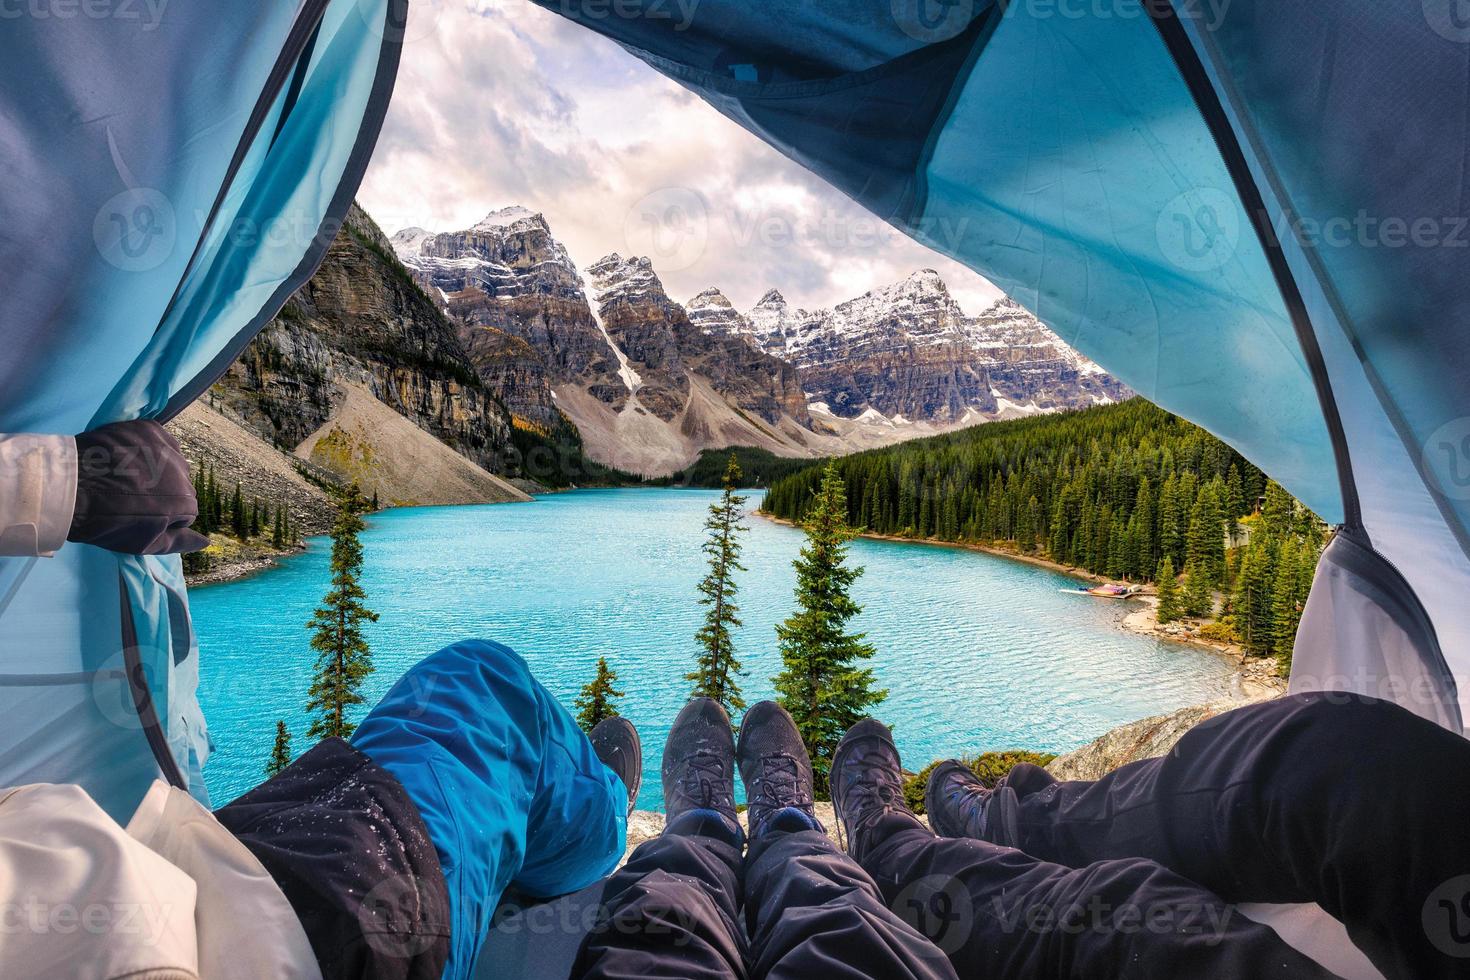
[0,782,322,980]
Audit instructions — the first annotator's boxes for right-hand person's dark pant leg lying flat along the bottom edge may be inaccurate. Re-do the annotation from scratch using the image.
[863,821,1332,980]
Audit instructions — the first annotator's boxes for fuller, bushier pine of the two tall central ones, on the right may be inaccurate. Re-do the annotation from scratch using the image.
[772,463,888,793]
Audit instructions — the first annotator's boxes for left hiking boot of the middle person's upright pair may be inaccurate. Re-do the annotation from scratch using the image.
[663,698,739,836]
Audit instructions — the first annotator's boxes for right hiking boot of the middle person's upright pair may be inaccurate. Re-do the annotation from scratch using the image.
[735,701,822,839]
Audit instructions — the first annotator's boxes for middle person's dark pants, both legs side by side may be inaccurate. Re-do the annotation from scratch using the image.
[572,814,956,980]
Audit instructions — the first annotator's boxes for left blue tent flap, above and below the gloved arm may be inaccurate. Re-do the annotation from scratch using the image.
[0,0,406,818]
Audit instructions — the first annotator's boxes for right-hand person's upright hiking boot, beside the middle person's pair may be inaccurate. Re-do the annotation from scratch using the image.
[832,718,923,861]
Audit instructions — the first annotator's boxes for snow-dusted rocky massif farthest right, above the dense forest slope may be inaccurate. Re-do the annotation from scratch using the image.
[691,269,1129,425]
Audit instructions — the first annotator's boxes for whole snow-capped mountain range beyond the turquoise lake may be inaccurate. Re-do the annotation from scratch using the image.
[391,207,1129,473]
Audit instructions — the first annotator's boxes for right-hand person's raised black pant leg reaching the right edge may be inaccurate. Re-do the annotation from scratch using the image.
[985,693,1470,980]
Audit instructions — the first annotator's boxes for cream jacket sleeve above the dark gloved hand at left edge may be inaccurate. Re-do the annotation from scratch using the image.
[0,433,76,557]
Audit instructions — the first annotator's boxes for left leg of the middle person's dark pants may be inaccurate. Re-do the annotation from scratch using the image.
[572,813,747,980]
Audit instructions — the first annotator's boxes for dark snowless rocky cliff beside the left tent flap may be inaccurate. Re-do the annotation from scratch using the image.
[212,204,510,469]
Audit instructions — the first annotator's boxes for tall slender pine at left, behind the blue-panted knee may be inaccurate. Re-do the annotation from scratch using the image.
[306,483,378,739]
